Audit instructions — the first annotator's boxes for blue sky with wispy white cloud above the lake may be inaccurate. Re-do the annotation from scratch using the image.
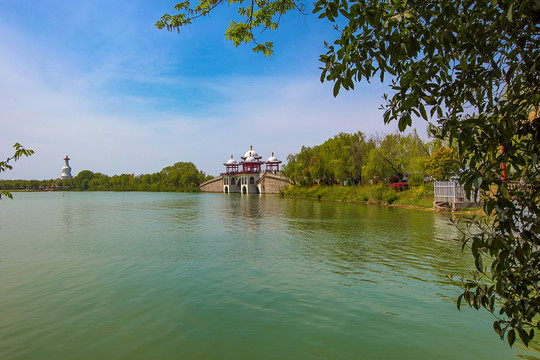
[0,0,426,179]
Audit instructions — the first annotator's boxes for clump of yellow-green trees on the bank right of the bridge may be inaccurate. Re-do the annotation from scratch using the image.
[283,132,450,186]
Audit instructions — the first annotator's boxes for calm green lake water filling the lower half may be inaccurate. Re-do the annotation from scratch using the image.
[0,192,539,360]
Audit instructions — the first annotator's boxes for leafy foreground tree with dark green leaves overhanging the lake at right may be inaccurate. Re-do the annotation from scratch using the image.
[157,0,540,345]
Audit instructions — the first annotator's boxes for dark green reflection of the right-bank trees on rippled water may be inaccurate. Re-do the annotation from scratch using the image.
[286,201,471,281]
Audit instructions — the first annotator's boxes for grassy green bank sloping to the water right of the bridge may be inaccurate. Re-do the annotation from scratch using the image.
[283,184,433,208]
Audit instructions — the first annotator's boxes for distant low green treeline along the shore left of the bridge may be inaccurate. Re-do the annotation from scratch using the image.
[0,162,213,192]
